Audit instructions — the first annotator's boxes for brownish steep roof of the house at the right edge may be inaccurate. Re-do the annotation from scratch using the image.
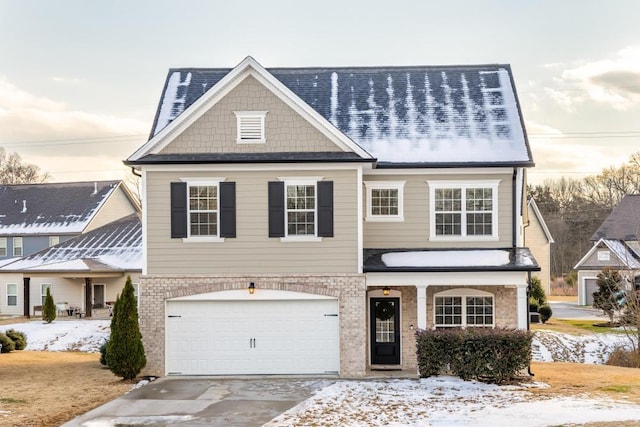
[590,194,640,241]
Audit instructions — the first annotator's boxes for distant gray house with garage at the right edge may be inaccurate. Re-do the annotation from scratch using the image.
[573,194,640,305]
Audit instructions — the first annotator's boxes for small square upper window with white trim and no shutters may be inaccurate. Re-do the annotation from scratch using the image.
[364,181,405,221]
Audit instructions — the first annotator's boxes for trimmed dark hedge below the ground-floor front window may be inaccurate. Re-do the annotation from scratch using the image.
[416,328,533,384]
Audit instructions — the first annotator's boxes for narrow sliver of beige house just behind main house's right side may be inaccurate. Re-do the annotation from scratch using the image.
[524,197,553,295]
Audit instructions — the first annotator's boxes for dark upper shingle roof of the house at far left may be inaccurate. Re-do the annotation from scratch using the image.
[0,181,120,235]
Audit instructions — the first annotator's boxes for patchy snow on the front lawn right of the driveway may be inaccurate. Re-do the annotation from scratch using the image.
[265,376,640,427]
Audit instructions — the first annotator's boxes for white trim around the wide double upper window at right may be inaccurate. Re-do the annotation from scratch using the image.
[426,179,500,242]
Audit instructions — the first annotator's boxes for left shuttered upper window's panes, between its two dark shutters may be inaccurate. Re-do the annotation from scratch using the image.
[188,183,219,237]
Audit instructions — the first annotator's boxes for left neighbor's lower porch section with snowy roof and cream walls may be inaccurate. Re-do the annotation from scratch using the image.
[0,213,142,317]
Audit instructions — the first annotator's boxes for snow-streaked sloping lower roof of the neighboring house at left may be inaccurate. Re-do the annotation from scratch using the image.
[0,214,142,272]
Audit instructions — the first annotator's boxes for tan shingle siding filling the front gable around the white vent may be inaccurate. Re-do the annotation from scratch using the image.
[161,76,342,154]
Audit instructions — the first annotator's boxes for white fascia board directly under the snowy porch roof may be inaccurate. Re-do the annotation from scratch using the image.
[365,271,527,287]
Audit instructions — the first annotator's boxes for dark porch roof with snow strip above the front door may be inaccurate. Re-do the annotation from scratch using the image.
[363,248,540,273]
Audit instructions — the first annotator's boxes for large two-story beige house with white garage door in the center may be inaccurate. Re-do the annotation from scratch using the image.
[125,57,539,377]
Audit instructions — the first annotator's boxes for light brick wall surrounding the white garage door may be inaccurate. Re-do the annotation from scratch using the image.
[140,274,367,377]
